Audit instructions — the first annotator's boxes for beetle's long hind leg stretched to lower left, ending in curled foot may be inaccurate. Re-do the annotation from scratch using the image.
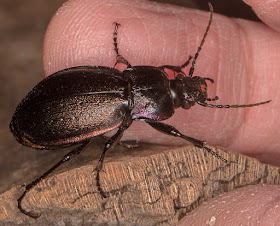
[17,140,90,218]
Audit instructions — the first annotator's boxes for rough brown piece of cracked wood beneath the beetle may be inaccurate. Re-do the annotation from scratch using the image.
[0,142,280,225]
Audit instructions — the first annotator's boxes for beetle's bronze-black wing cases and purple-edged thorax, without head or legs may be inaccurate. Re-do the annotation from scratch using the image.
[10,66,182,149]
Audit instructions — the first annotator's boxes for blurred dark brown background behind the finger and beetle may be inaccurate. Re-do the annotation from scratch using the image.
[0,0,258,193]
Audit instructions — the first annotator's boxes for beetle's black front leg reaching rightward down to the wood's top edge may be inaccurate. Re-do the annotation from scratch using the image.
[145,120,227,163]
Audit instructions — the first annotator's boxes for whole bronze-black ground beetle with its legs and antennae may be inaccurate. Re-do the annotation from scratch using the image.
[10,3,270,218]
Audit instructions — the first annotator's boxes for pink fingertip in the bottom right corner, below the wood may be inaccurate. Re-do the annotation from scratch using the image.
[179,184,280,226]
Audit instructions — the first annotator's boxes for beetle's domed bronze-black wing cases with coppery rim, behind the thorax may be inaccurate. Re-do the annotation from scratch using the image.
[10,67,128,148]
